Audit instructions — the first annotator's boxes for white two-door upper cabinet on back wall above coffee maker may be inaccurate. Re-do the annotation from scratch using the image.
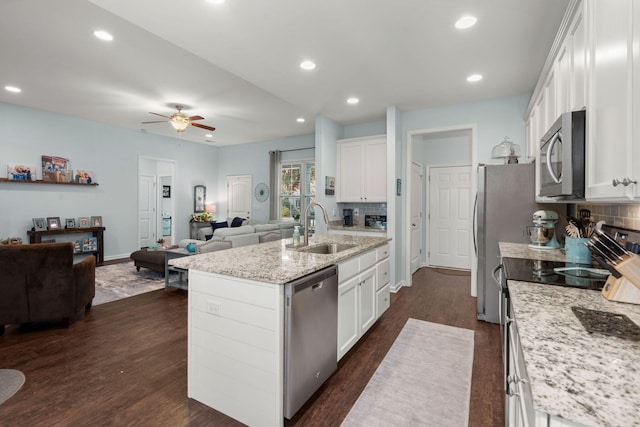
[336,135,387,203]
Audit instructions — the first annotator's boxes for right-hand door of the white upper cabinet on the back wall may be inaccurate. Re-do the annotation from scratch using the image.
[363,139,387,203]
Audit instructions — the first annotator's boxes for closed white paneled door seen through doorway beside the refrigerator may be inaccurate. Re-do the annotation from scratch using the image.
[429,166,472,269]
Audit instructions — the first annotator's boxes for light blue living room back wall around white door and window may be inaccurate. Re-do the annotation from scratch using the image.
[215,134,315,221]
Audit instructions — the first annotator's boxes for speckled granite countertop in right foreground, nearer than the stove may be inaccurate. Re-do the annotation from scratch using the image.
[510,280,640,427]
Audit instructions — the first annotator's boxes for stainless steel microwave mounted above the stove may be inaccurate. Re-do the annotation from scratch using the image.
[538,110,586,199]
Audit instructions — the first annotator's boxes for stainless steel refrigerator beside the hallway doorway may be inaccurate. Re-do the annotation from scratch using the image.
[474,163,538,323]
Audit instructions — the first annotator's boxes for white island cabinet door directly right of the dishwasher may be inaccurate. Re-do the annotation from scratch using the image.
[338,276,360,360]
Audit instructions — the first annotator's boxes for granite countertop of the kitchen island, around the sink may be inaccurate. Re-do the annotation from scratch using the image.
[169,234,391,284]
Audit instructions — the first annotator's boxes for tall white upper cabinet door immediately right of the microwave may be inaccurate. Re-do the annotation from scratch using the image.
[585,0,633,200]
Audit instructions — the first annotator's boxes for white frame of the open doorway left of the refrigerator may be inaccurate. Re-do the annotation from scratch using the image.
[404,123,478,297]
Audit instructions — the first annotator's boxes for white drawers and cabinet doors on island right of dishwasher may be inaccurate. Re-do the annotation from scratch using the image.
[337,245,390,360]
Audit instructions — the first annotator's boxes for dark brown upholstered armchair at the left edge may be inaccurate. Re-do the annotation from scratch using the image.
[0,242,96,335]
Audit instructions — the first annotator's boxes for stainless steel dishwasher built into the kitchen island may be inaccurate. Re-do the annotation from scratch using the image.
[284,266,338,419]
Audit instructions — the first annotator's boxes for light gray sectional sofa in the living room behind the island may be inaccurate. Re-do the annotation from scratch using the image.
[179,218,300,253]
